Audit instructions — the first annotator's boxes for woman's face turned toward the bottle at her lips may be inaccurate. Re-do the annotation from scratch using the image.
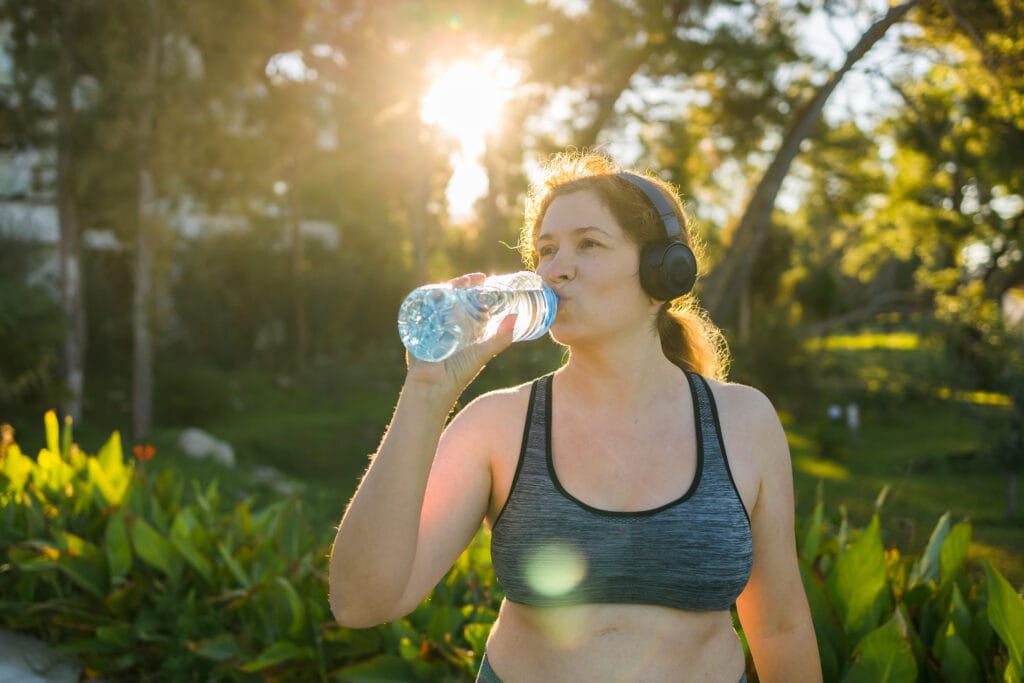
[536,189,657,345]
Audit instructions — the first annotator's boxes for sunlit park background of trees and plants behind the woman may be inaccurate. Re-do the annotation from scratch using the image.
[0,0,1024,680]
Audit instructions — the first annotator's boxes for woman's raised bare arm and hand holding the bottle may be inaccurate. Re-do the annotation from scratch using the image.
[329,275,515,627]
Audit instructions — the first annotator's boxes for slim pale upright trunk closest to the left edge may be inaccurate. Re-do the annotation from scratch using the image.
[55,2,86,421]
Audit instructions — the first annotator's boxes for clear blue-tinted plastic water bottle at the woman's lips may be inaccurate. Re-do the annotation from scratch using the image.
[398,270,558,362]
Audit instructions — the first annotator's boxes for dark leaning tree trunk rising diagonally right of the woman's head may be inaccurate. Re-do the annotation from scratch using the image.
[700,0,921,326]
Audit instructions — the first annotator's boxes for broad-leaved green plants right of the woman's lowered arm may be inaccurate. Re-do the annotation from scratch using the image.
[799,483,1024,683]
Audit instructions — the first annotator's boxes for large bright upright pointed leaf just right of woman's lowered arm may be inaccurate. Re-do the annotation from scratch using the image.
[825,515,892,641]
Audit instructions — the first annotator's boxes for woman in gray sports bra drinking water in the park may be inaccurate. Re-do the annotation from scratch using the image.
[330,155,821,683]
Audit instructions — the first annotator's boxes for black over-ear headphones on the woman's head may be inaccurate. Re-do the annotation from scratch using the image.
[615,173,697,301]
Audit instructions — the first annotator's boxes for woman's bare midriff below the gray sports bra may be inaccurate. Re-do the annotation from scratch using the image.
[487,600,743,683]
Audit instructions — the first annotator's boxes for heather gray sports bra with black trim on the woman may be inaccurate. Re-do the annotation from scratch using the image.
[490,373,754,611]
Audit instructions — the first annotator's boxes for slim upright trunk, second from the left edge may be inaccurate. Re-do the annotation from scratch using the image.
[132,0,160,441]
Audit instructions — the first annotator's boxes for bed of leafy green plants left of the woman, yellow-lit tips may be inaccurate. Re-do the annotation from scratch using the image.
[0,413,501,681]
